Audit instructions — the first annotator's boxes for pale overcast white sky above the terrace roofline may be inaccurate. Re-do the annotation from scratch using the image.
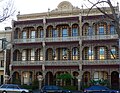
[0,0,120,30]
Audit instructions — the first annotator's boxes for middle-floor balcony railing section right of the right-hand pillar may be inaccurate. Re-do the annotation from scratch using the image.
[82,59,120,65]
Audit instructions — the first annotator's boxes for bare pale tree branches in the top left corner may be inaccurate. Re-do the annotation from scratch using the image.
[0,0,15,23]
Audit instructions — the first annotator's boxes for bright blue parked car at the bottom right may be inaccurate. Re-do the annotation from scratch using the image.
[84,85,119,93]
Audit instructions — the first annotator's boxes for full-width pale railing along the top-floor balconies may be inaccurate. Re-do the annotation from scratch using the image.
[14,34,118,43]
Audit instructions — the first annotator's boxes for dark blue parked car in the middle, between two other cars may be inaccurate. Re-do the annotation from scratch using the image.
[41,85,72,93]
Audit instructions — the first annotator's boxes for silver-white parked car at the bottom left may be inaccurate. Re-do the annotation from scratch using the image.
[0,84,32,93]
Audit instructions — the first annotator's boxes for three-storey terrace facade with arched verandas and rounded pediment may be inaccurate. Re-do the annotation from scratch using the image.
[11,1,120,88]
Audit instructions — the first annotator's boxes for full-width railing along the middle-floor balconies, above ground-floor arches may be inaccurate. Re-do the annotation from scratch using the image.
[12,59,120,66]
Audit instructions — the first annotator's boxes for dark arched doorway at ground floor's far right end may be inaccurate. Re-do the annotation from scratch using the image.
[111,71,119,89]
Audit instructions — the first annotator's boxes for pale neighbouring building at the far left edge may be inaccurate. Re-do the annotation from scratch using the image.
[0,27,12,85]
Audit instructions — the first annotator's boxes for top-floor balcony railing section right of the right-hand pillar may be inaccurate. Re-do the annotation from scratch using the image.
[82,34,118,40]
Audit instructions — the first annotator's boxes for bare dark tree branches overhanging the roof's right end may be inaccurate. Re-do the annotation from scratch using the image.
[88,0,120,38]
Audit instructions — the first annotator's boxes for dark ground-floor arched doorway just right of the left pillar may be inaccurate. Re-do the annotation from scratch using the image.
[45,72,54,85]
